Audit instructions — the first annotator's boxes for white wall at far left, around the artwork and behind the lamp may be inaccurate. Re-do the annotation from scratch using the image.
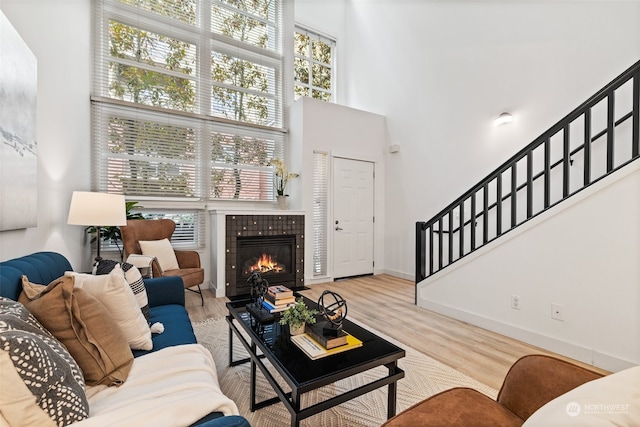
[0,0,92,270]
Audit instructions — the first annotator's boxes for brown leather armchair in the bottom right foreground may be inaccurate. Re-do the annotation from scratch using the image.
[383,354,602,427]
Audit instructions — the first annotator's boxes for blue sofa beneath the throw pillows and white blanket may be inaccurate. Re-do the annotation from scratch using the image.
[0,252,249,427]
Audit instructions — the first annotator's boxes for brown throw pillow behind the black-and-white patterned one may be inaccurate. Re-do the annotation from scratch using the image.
[27,276,133,386]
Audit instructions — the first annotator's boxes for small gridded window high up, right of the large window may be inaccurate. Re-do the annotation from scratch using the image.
[294,26,336,101]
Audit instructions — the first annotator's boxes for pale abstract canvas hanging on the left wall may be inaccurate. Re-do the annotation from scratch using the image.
[0,11,38,231]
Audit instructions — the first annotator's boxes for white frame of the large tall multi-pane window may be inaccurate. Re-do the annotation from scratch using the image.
[91,0,292,202]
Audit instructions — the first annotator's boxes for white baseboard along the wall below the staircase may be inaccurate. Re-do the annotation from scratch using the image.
[418,300,637,372]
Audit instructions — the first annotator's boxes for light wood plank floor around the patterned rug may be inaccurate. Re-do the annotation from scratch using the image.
[187,275,606,389]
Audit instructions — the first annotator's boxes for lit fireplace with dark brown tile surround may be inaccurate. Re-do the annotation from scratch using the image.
[225,215,304,297]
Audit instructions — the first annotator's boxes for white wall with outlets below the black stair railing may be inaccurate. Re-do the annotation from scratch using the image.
[418,161,640,371]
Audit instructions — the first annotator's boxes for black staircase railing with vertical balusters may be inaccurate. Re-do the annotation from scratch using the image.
[415,61,640,285]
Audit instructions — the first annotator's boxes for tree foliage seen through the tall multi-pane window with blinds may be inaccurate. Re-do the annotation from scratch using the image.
[99,0,282,200]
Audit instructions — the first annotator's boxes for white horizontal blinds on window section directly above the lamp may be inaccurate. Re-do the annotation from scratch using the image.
[93,103,203,198]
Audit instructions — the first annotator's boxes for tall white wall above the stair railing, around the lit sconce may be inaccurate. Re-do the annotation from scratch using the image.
[339,0,640,277]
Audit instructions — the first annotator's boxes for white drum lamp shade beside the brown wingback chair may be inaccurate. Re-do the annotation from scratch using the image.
[67,191,127,227]
